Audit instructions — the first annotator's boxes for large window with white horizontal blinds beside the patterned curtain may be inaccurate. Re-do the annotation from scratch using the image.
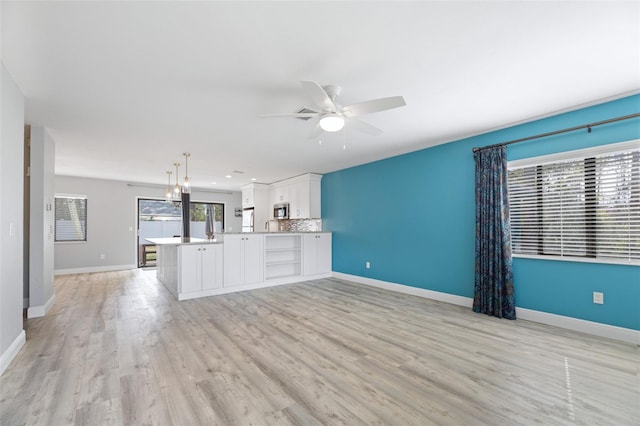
[508,141,640,265]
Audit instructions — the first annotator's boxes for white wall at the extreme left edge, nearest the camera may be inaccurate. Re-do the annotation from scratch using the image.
[0,64,25,374]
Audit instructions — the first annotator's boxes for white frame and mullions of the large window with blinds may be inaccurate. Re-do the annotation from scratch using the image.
[507,139,640,266]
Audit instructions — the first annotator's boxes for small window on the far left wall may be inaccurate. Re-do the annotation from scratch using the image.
[55,195,87,242]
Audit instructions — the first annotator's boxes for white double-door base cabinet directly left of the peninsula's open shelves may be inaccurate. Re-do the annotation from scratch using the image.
[223,235,264,287]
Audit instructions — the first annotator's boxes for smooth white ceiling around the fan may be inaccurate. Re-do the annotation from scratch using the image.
[1,1,640,189]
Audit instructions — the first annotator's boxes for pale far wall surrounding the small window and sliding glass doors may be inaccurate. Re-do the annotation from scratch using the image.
[54,176,242,274]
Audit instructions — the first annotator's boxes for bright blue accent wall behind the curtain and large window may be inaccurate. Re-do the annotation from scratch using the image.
[322,95,640,330]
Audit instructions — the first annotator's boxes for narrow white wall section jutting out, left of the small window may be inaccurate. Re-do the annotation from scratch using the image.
[27,126,55,318]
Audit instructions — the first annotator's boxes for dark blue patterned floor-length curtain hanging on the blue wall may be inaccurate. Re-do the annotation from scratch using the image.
[473,146,516,319]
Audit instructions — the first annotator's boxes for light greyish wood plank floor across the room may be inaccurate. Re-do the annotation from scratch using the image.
[0,270,640,425]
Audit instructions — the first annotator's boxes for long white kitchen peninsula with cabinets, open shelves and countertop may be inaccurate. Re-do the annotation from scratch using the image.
[148,232,331,300]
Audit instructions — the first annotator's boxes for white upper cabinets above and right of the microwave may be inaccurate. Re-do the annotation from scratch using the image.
[269,173,322,219]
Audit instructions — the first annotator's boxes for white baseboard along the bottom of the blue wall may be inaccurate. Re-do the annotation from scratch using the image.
[333,272,640,345]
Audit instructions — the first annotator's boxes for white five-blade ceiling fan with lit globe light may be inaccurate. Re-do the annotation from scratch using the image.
[262,81,406,137]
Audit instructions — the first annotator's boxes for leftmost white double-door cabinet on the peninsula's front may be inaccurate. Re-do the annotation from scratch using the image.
[177,244,223,294]
